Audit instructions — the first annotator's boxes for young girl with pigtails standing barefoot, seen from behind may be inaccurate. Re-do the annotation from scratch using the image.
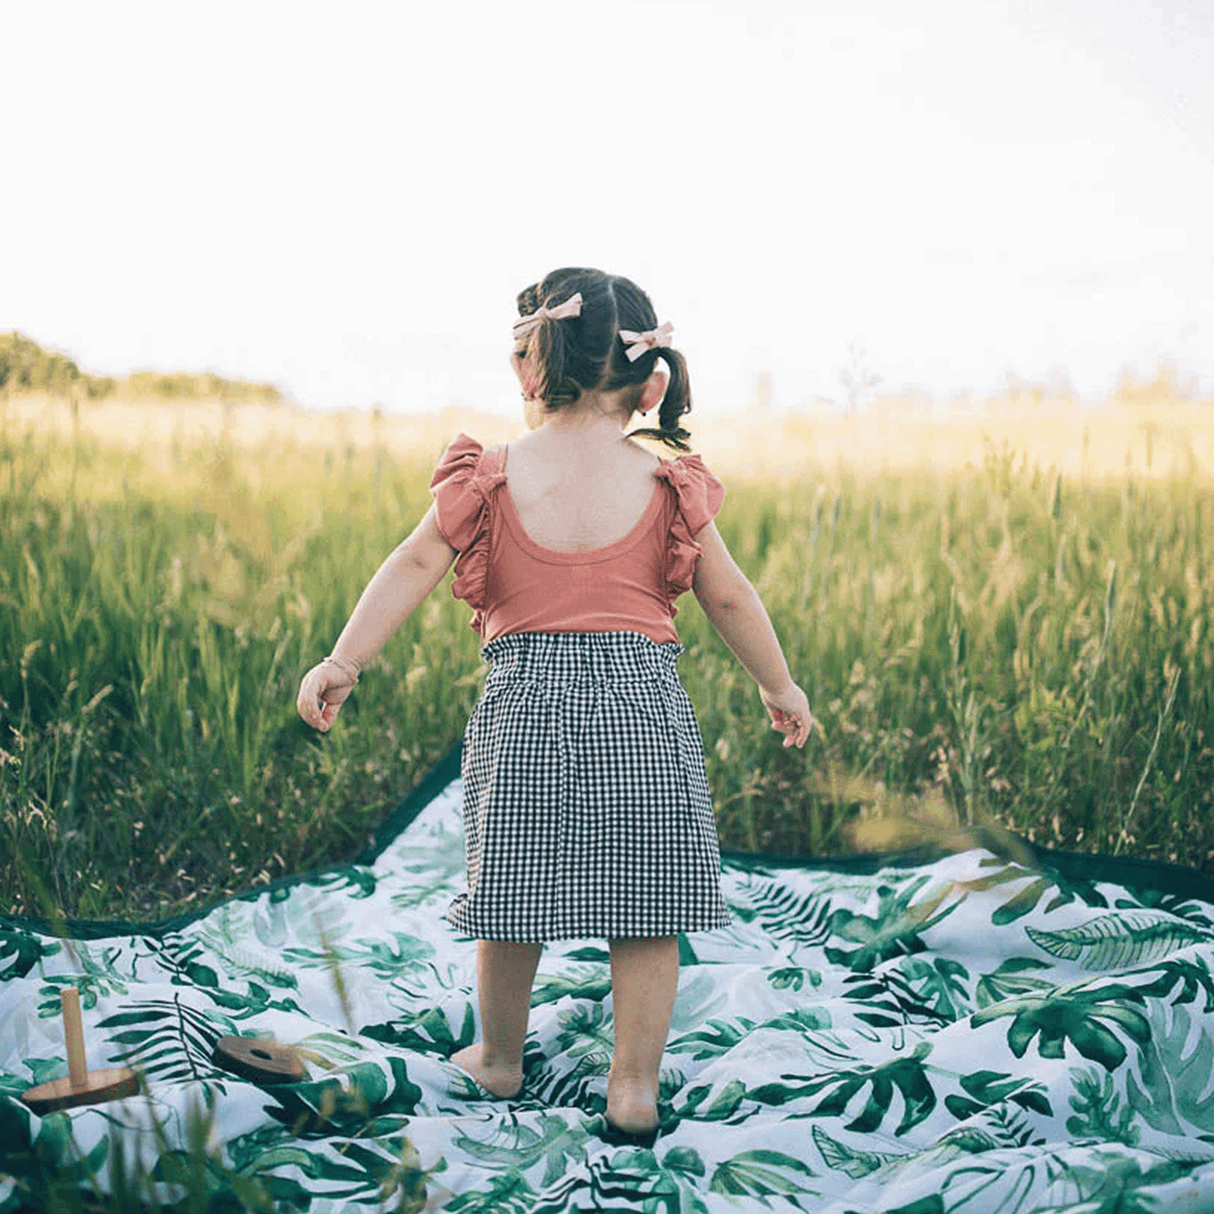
[299,270,812,1139]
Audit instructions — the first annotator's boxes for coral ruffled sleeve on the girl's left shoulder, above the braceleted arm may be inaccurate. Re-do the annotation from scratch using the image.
[430,435,506,630]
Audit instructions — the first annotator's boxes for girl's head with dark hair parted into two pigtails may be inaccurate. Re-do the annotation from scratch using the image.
[515,268,691,452]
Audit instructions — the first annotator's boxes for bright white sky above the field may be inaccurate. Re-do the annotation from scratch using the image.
[0,0,1214,412]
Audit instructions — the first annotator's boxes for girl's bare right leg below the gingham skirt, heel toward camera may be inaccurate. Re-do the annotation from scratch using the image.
[607,936,679,1133]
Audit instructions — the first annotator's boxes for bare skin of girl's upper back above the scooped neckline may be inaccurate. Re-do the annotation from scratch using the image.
[505,421,659,552]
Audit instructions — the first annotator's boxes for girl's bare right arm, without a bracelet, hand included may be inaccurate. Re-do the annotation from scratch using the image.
[692,523,813,747]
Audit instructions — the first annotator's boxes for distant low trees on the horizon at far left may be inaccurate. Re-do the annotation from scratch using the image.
[0,333,283,404]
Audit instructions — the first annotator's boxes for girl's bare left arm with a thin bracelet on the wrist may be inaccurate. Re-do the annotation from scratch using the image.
[296,506,456,730]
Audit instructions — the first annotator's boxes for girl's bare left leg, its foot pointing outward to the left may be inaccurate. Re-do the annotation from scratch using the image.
[452,940,544,1096]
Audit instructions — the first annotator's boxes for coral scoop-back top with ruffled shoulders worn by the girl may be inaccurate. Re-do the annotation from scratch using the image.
[430,435,725,645]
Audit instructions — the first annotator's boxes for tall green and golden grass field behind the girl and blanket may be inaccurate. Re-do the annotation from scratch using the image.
[0,388,1214,919]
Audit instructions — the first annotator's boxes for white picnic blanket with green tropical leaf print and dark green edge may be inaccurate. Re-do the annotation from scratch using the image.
[0,738,1214,1214]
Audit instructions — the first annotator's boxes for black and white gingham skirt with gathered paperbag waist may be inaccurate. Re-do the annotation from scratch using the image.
[447,632,730,942]
